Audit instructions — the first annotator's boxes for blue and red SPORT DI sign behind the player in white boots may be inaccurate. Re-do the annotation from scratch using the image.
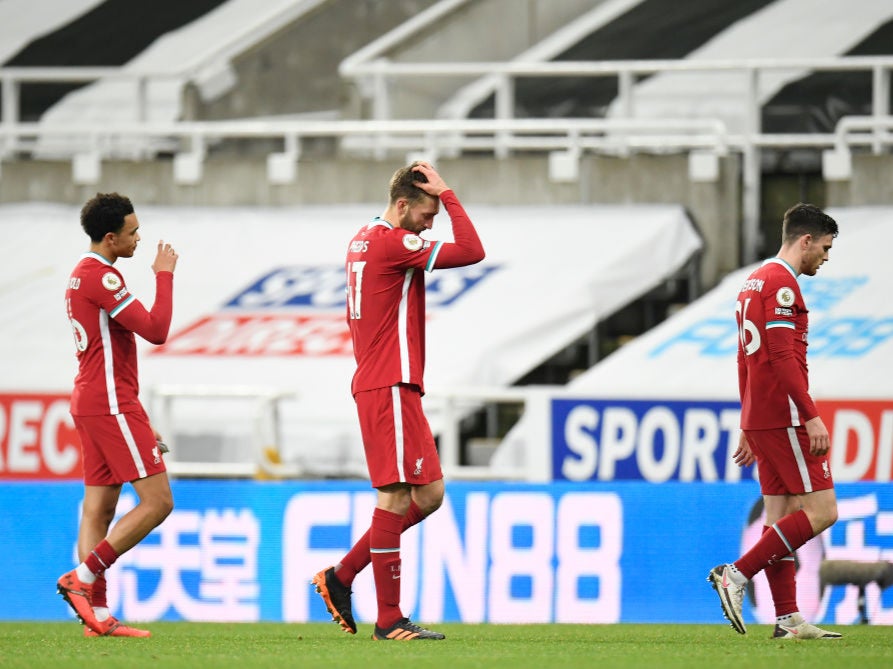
[552,399,893,483]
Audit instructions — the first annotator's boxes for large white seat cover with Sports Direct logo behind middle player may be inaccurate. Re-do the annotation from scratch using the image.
[0,203,701,474]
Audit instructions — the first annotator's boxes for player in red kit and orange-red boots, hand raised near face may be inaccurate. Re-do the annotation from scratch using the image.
[57,193,177,637]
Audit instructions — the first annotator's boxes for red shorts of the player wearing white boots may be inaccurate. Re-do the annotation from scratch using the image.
[744,425,834,495]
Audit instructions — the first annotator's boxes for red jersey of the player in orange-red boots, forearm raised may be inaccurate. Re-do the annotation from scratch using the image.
[65,252,173,416]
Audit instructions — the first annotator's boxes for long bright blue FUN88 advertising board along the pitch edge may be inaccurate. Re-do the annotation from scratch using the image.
[0,480,893,624]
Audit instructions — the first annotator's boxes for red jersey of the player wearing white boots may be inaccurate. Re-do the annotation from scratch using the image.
[735,258,818,430]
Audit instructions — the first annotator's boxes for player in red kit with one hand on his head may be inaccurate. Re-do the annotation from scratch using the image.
[313,161,484,641]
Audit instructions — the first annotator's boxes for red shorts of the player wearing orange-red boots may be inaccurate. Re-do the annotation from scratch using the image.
[73,407,165,485]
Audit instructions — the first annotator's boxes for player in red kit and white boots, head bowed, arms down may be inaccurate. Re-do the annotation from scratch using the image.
[707,204,841,639]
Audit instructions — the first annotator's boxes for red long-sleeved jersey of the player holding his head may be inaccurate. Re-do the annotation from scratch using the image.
[346,191,484,394]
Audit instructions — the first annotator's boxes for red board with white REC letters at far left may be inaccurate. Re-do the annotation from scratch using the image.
[0,393,83,479]
